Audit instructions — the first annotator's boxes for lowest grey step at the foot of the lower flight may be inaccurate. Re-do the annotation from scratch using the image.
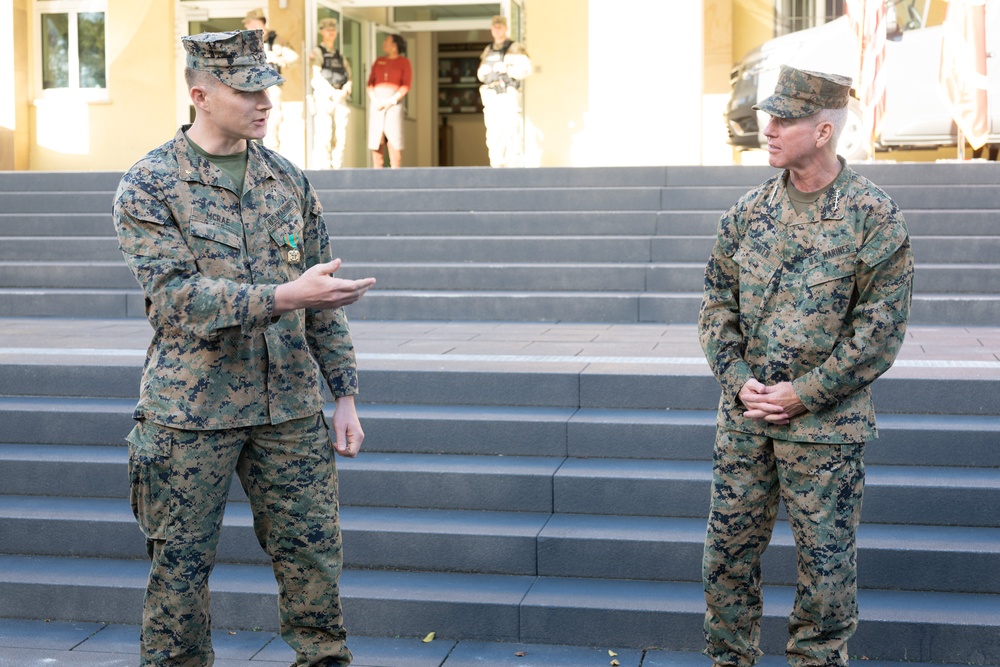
[0,556,1000,664]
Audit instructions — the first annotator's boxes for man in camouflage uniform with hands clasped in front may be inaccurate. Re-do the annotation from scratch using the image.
[699,67,913,667]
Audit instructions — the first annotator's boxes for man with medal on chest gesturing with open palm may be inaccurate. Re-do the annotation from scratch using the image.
[114,31,374,667]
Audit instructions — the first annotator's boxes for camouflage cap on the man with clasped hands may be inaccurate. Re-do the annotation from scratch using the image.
[753,65,851,118]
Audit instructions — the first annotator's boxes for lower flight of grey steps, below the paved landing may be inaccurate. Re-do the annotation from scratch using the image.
[0,348,1000,664]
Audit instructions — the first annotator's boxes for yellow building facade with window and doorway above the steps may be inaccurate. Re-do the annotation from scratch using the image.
[0,0,940,171]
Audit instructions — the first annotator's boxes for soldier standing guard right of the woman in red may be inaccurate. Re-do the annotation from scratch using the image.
[476,16,531,167]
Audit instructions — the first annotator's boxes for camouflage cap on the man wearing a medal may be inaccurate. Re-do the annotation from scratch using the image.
[181,30,285,92]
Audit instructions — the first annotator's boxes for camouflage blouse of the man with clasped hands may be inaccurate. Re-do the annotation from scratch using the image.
[699,161,913,443]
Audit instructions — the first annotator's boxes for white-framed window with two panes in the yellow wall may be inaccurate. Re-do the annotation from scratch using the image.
[34,0,108,97]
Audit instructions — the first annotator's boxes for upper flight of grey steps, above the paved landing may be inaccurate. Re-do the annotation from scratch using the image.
[0,164,1000,325]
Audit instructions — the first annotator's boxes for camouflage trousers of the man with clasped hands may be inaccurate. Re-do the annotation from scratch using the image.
[702,428,865,667]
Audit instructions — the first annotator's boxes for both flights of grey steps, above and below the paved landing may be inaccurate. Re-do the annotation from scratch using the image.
[0,165,1000,665]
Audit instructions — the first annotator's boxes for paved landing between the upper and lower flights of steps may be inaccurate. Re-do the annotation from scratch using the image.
[0,318,1000,379]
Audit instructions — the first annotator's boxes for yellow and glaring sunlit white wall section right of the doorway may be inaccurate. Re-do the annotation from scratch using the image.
[525,0,704,166]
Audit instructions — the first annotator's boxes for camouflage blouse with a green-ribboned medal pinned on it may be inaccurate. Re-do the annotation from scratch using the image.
[114,127,358,430]
